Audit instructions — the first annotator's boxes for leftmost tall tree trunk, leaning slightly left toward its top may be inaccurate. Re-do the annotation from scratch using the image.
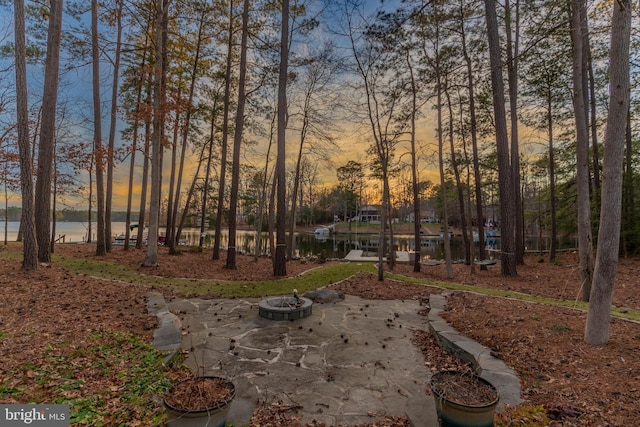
[13,0,38,271]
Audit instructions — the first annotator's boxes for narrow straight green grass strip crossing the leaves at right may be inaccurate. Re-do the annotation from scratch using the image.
[385,272,640,322]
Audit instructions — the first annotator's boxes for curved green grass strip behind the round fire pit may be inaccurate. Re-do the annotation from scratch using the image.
[55,257,373,298]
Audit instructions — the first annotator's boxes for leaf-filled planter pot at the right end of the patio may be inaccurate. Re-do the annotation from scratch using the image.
[430,371,499,427]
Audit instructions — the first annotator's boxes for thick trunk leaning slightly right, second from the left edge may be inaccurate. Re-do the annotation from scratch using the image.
[35,0,63,262]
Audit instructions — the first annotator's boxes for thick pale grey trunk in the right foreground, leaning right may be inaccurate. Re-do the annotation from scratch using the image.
[584,0,632,345]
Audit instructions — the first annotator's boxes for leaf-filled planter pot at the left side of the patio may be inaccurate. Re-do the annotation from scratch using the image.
[164,376,236,427]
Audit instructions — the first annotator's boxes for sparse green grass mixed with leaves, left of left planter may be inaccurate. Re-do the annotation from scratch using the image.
[0,331,170,426]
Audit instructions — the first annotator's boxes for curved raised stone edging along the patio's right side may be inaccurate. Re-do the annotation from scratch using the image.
[428,294,523,410]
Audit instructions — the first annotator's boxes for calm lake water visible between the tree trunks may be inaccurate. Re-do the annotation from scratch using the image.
[0,221,575,260]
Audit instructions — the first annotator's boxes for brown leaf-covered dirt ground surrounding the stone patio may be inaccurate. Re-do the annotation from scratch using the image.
[0,245,640,427]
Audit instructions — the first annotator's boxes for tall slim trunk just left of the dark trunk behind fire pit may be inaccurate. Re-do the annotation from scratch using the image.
[226,0,250,270]
